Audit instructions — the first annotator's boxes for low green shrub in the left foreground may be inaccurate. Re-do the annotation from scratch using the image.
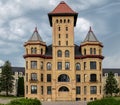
[7,99,42,105]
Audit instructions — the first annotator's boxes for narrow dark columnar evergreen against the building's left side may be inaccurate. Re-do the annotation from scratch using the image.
[17,77,24,96]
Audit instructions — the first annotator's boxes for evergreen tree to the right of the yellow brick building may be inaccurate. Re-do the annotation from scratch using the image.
[104,72,118,96]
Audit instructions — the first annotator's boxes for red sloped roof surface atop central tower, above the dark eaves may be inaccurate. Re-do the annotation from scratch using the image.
[50,1,76,14]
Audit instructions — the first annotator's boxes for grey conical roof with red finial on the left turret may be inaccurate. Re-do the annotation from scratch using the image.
[28,27,43,42]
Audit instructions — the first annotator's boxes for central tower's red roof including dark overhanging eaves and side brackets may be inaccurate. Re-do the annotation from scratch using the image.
[48,1,78,26]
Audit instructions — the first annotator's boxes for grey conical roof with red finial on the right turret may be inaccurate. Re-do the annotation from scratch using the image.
[84,27,99,42]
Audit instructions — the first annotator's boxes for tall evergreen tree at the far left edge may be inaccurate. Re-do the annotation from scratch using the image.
[0,61,14,96]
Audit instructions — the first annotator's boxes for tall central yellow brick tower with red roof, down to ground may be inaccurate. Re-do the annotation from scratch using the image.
[48,1,78,100]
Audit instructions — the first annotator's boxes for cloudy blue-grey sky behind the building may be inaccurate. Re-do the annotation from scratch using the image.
[0,0,120,68]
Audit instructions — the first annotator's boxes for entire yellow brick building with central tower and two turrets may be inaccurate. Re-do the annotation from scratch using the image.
[24,1,104,101]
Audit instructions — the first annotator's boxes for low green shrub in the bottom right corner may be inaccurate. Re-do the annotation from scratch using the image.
[87,98,120,105]
